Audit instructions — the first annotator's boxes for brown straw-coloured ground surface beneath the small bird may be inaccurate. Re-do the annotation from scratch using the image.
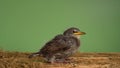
[0,51,120,68]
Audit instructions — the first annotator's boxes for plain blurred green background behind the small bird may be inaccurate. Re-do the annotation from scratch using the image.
[0,0,120,52]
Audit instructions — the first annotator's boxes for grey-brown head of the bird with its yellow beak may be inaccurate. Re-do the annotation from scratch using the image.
[63,27,86,39]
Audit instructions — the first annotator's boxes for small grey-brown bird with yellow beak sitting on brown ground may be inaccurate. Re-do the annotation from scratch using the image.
[29,27,86,63]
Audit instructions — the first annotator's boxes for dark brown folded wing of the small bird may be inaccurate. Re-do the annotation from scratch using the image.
[40,35,76,54]
